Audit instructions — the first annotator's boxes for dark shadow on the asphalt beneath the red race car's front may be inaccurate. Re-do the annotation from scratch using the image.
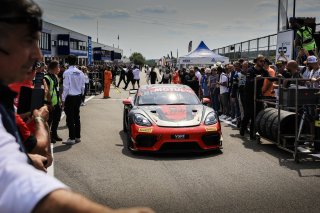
[116,131,222,161]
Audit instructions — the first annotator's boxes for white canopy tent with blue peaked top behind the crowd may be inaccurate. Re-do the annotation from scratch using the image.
[178,41,229,64]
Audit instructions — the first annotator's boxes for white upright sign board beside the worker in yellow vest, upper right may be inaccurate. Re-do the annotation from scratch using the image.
[276,30,294,61]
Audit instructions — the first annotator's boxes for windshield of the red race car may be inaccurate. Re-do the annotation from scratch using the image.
[138,92,200,106]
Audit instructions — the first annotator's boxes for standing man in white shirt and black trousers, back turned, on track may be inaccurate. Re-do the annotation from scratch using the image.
[62,55,85,145]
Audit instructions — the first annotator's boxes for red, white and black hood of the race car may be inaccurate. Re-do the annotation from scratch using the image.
[139,105,204,127]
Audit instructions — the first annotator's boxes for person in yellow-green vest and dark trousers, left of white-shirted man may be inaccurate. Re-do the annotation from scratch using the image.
[44,61,62,143]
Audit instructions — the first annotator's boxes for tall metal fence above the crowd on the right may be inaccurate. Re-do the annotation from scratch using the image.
[213,24,320,62]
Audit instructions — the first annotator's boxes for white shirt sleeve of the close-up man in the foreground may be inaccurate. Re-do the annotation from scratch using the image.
[0,114,67,213]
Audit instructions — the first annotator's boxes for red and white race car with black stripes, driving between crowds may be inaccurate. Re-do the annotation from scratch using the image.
[123,84,222,152]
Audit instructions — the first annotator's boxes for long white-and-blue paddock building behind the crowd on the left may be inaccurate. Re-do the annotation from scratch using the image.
[39,21,123,65]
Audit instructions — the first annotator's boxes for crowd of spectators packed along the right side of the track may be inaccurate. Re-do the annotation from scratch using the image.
[140,52,320,139]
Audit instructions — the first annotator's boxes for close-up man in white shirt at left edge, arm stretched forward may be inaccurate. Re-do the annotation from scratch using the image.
[0,0,153,213]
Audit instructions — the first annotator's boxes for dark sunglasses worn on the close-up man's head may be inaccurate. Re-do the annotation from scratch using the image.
[0,16,42,32]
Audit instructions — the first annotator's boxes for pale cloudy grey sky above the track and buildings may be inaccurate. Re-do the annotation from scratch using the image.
[35,0,320,59]
